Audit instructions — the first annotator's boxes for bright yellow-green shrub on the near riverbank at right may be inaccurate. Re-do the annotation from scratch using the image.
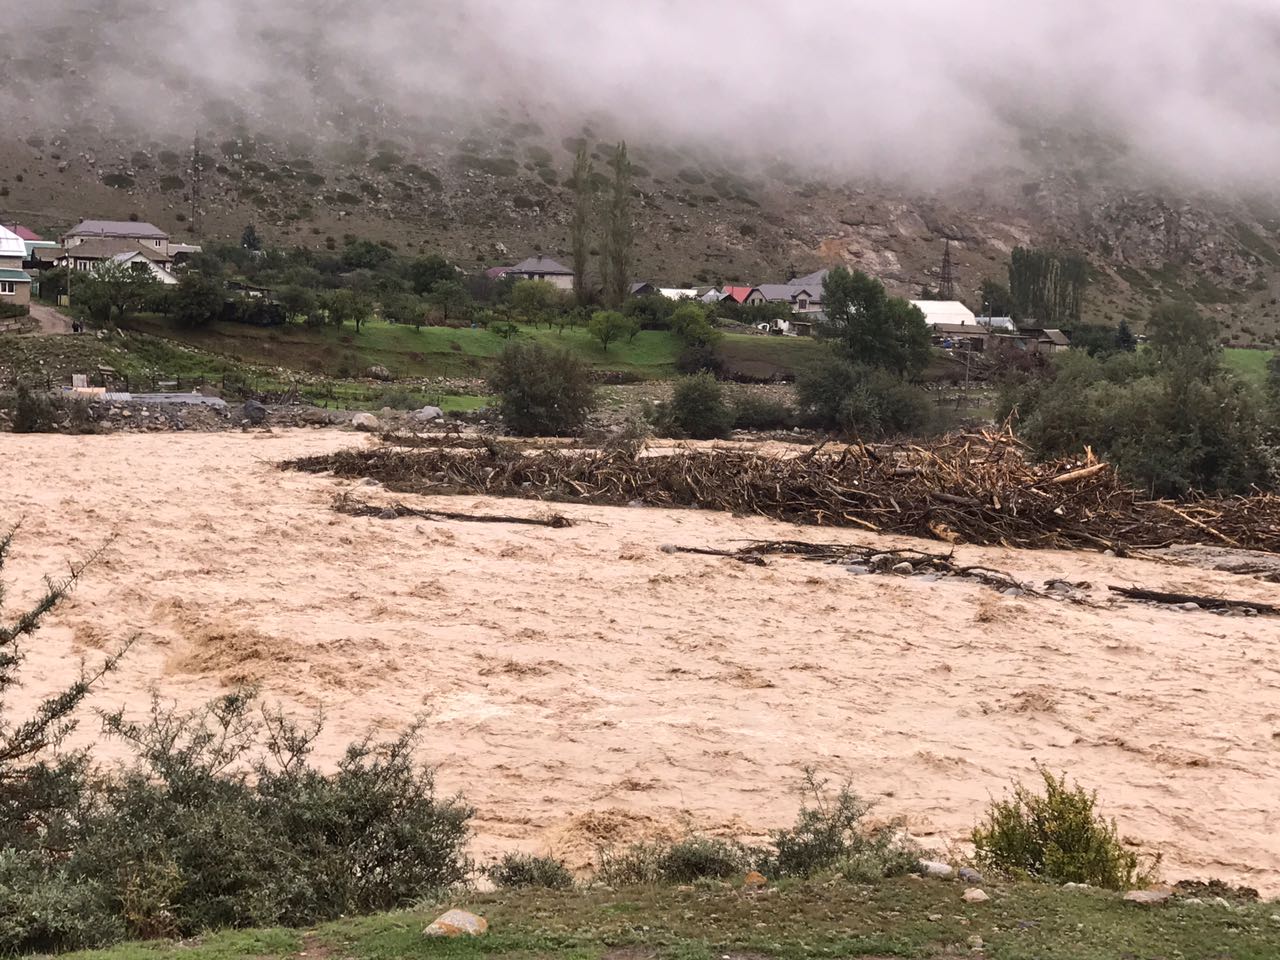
[973,767,1156,890]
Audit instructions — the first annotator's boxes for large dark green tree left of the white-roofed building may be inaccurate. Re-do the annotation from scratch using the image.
[819,266,932,376]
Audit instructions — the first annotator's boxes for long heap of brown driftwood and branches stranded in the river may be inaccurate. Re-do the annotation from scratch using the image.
[285,433,1280,554]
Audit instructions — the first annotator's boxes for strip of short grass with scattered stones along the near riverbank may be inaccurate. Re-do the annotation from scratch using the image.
[62,878,1280,960]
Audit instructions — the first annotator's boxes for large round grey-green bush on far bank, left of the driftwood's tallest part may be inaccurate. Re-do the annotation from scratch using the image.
[489,342,595,436]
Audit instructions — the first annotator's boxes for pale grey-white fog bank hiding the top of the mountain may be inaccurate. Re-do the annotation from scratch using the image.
[0,0,1280,187]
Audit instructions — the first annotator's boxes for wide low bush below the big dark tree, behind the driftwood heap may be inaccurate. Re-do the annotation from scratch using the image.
[796,356,933,439]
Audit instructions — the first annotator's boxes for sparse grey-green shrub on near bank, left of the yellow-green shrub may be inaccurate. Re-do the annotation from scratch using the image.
[765,771,919,879]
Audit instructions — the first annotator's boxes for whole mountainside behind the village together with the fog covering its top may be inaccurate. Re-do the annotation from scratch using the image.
[0,0,1280,335]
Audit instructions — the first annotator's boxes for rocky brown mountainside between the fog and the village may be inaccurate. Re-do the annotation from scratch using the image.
[0,116,1280,343]
